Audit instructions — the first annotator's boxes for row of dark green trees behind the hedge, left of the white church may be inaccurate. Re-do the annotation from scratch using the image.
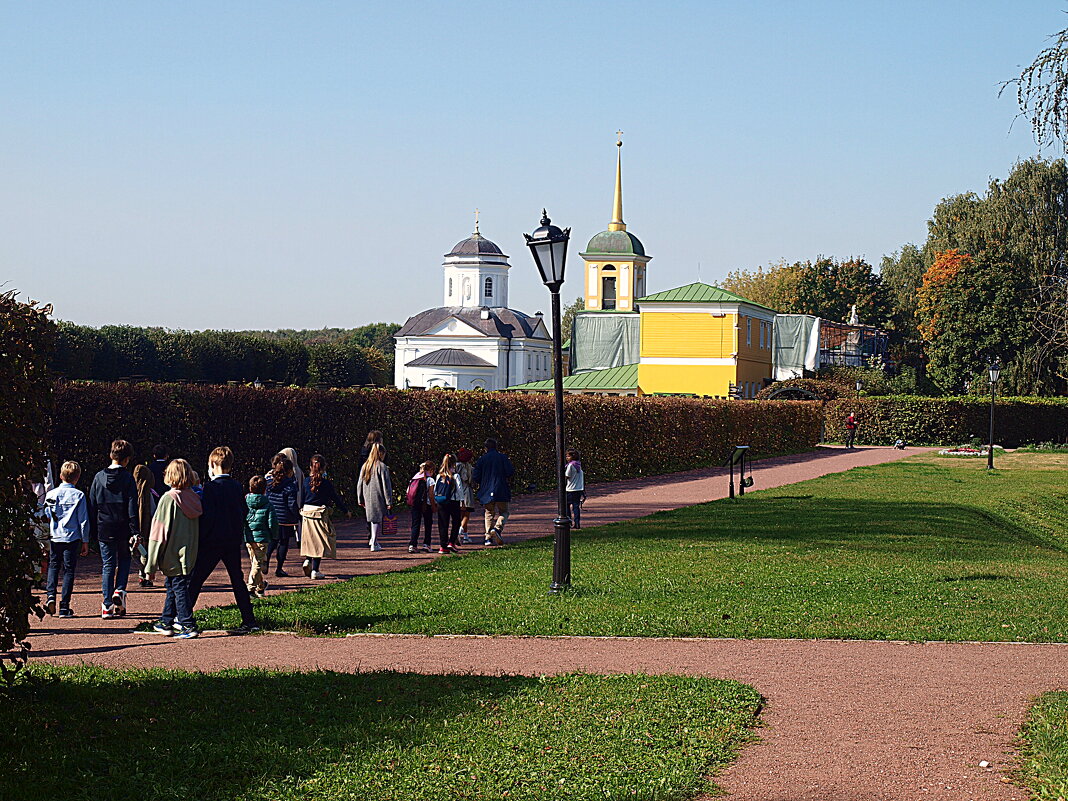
[49,323,399,387]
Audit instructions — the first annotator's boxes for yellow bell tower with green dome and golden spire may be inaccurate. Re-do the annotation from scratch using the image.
[579,130,651,312]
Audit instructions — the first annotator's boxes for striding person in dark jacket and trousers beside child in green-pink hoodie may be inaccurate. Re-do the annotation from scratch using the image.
[189,447,260,634]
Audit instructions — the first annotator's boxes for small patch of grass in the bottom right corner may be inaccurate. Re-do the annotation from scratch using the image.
[1020,692,1068,801]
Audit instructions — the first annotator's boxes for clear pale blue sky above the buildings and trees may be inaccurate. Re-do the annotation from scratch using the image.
[0,0,1068,329]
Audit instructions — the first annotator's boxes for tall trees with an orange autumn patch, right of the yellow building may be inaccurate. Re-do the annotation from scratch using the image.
[723,158,1068,395]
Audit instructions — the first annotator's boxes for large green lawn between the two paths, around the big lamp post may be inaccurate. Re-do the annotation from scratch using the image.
[198,454,1068,641]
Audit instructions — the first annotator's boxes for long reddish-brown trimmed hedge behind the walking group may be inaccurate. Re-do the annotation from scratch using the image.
[49,382,821,498]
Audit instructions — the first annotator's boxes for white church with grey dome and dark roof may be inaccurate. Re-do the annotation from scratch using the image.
[394,220,552,391]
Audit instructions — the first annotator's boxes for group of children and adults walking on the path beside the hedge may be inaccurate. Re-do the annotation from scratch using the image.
[35,431,585,639]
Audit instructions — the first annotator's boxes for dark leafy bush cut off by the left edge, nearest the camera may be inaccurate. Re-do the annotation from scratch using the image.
[0,292,56,677]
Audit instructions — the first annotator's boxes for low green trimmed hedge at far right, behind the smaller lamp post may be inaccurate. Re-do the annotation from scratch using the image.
[824,395,1068,447]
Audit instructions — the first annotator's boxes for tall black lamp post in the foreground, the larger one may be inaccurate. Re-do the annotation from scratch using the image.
[523,208,571,594]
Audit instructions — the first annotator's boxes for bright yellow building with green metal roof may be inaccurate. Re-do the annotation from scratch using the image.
[638,283,775,397]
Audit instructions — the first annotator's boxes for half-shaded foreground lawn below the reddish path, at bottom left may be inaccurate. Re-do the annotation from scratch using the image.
[0,665,759,801]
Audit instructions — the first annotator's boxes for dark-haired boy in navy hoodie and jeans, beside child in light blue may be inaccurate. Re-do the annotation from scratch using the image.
[89,439,140,618]
